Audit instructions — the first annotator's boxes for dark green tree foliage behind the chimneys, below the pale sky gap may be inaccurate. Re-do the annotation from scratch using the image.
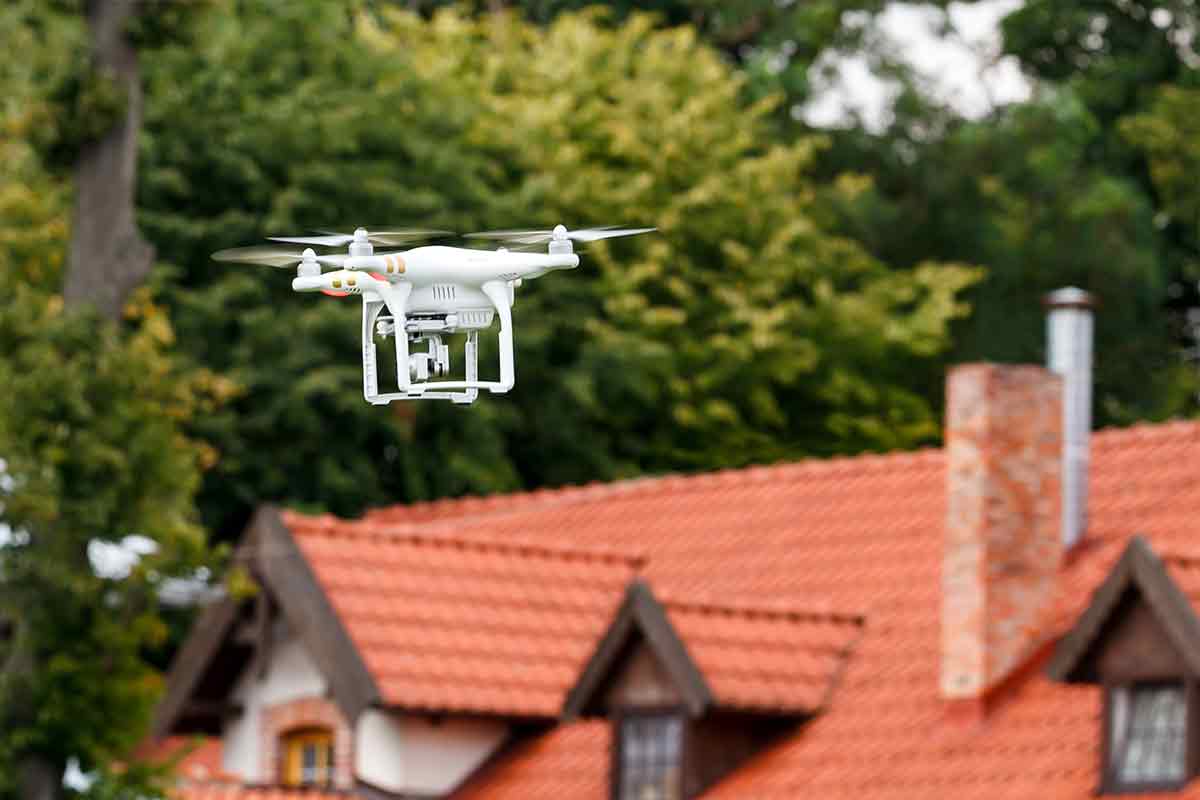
[833,91,1186,425]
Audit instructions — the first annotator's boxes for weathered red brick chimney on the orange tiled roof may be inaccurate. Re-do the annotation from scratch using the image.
[941,363,1064,699]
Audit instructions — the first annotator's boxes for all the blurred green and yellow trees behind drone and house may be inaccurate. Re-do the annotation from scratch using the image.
[0,0,1200,796]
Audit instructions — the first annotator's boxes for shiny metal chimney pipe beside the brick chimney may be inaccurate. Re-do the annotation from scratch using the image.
[1043,287,1096,551]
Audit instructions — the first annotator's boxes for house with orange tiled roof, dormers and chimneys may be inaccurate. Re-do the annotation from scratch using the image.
[156,290,1200,800]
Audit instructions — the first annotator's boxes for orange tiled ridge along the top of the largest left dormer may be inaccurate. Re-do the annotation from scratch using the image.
[284,511,647,571]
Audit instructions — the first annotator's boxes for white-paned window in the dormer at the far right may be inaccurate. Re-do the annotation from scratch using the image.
[1106,681,1188,790]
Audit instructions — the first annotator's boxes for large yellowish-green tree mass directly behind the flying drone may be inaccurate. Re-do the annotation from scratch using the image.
[133,4,977,537]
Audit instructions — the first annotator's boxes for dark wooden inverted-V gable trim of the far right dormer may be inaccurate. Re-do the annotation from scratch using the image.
[1046,536,1200,682]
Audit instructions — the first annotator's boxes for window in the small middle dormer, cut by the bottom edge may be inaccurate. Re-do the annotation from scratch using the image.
[617,714,683,800]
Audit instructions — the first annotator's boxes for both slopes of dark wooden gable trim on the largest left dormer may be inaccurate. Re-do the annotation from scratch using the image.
[154,506,380,736]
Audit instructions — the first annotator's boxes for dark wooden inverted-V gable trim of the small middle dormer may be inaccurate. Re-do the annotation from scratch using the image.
[563,579,713,720]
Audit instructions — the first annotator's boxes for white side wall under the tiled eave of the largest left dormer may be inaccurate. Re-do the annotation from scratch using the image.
[354,709,508,795]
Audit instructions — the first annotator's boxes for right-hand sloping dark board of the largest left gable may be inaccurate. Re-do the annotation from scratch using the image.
[251,506,382,723]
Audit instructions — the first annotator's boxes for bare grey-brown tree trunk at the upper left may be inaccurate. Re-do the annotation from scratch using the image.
[62,0,154,319]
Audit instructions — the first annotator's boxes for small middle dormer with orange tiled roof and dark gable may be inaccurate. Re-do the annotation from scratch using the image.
[564,579,862,800]
